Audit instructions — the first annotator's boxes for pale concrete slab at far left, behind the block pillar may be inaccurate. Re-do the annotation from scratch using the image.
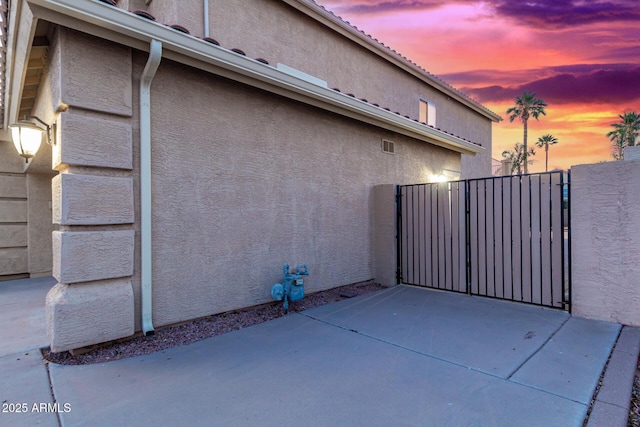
[0,277,56,356]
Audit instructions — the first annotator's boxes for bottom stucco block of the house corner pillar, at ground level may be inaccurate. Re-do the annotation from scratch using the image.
[46,279,134,352]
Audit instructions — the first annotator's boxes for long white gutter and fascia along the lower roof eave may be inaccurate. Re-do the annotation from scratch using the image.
[25,0,484,155]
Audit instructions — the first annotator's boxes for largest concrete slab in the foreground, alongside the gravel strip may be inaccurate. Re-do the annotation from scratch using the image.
[51,314,586,427]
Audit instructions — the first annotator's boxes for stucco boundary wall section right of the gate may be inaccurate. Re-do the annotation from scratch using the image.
[571,160,640,326]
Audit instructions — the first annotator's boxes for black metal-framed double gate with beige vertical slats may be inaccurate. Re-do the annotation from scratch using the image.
[397,171,571,310]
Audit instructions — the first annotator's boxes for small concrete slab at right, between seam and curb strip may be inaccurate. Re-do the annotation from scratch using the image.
[511,317,620,404]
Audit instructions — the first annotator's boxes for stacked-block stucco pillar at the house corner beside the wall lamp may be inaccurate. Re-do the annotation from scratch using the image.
[46,28,135,352]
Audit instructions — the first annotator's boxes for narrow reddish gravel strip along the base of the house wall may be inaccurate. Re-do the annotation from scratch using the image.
[42,281,385,365]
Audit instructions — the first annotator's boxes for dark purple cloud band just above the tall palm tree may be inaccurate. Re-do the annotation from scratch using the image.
[461,66,640,104]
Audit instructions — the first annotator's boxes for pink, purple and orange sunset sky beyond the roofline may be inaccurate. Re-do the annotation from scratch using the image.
[316,0,640,172]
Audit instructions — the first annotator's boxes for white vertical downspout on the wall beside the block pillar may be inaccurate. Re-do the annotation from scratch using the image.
[140,40,162,335]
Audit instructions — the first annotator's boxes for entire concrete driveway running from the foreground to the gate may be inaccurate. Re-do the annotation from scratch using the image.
[0,280,636,427]
